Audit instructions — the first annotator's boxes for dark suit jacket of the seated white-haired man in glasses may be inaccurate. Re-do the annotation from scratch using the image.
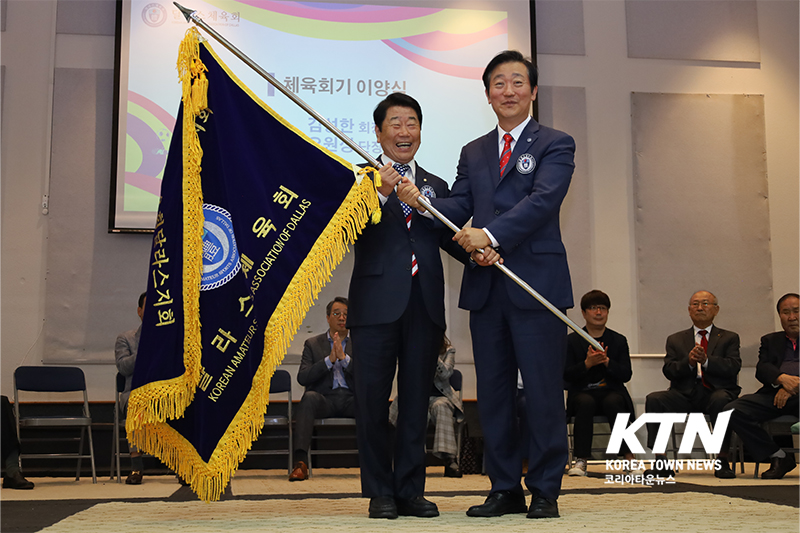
[662,326,742,396]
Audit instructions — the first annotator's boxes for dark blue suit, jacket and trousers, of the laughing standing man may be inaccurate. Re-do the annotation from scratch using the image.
[347,157,467,499]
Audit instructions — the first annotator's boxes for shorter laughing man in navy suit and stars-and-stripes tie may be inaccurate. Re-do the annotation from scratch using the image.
[347,93,468,518]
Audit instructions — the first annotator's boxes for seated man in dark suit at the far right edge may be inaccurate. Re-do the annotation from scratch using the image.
[725,293,800,479]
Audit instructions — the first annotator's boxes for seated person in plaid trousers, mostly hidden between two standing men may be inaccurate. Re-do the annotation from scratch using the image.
[389,336,464,477]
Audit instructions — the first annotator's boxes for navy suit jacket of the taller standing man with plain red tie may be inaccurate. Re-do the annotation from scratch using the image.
[432,115,575,310]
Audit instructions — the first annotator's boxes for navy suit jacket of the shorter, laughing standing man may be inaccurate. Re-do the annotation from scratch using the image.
[347,159,469,329]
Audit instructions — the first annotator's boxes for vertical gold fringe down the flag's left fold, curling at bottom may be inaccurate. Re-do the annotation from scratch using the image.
[126,27,208,434]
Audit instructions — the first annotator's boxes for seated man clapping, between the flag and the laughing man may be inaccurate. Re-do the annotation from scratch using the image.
[289,296,356,481]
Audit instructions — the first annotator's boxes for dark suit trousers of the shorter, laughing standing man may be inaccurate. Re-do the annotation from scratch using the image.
[350,271,444,499]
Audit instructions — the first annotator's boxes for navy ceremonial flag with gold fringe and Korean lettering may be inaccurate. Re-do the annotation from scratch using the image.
[127,28,379,501]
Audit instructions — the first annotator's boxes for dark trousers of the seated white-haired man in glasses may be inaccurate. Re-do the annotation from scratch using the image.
[645,379,736,453]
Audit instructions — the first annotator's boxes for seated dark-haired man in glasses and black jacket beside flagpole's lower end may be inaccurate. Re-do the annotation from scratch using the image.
[564,290,642,476]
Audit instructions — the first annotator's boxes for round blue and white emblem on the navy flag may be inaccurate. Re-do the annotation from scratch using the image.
[200,204,241,291]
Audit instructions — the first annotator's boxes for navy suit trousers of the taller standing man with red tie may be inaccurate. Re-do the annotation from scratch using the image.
[470,269,569,499]
